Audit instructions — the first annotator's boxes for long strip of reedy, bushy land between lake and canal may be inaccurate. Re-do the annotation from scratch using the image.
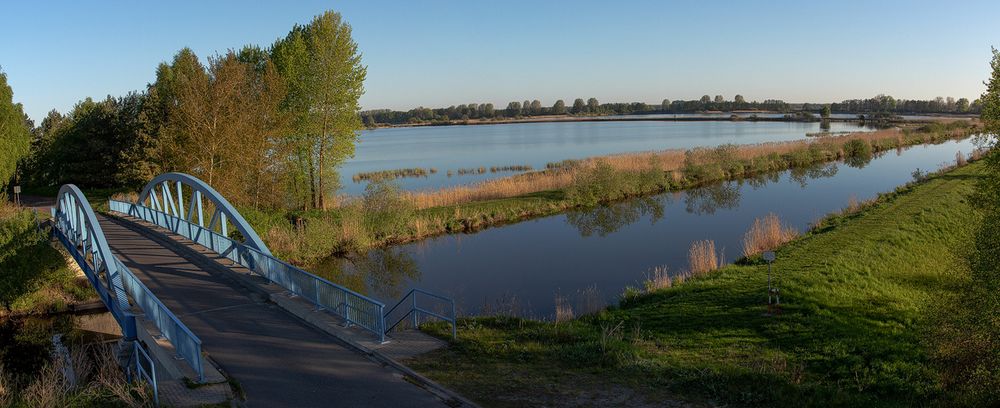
[254,122,976,264]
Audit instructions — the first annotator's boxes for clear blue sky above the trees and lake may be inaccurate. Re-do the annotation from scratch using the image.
[0,0,1000,119]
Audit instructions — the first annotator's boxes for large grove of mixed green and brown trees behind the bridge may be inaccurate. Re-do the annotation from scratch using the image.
[7,11,367,209]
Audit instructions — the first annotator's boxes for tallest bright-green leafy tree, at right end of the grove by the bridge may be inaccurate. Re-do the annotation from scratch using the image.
[271,11,367,208]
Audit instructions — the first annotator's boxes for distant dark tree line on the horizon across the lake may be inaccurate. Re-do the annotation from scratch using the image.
[361,95,982,127]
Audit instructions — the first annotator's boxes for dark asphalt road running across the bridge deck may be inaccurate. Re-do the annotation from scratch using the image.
[99,216,443,407]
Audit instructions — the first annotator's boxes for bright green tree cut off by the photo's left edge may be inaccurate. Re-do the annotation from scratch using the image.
[0,72,31,189]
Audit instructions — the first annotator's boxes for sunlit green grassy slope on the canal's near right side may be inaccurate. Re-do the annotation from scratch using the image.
[410,164,981,406]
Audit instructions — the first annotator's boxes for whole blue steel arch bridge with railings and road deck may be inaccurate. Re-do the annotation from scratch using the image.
[51,173,462,407]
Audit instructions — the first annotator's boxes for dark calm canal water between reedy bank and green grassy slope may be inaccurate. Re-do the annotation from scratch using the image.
[307,140,974,318]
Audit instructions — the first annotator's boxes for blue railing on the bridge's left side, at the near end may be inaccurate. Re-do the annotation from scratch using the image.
[115,258,205,382]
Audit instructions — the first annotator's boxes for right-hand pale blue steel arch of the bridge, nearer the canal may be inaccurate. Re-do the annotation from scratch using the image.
[136,173,271,256]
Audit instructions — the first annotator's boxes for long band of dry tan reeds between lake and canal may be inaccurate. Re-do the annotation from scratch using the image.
[410,122,969,209]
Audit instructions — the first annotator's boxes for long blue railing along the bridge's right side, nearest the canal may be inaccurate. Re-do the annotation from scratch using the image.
[108,200,386,341]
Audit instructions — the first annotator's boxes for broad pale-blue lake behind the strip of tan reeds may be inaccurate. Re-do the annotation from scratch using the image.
[340,121,870,195]
